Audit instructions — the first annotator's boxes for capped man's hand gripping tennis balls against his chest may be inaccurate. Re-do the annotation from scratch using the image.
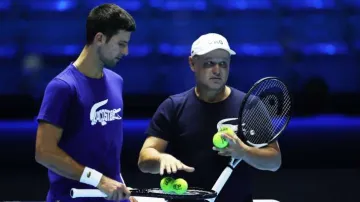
[213,133,249,159]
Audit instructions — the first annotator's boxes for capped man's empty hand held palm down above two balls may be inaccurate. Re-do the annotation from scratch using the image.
[159,154,195,175]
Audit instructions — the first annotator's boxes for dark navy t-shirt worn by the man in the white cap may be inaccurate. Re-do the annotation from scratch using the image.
[146,88,252,202]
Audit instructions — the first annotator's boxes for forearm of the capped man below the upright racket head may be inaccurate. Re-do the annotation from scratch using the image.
[243,147,281,171]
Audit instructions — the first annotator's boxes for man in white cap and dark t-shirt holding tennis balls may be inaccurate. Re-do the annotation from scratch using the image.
[138,33,281,202]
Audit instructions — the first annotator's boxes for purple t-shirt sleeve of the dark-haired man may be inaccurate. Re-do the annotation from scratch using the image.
[37,78,72,128]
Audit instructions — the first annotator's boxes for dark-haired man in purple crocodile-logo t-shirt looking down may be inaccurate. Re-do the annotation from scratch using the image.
[36,4,136,202]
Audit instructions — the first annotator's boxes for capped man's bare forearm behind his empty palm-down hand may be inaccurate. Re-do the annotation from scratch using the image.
[138,148,161,174]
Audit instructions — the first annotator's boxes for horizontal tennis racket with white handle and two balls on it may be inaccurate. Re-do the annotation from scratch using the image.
[70,187,217,200]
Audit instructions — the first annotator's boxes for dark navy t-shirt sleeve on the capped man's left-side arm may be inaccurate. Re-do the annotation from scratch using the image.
[145,98,175,141]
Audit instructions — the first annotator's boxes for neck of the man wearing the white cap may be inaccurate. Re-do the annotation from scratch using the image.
[195,86,231,103]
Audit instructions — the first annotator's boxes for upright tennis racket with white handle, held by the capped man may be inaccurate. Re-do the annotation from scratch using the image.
[207,77,292,202]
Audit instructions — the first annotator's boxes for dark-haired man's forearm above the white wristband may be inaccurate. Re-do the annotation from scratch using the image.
[36,148,84,181]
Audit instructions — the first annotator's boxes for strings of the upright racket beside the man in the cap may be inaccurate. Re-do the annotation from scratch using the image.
[242,80,291,144]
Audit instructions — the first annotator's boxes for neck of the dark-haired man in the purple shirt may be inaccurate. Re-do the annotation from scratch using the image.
[73,46,103,79]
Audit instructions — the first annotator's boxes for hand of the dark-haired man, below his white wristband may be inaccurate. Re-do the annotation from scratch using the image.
[97,176,131,201]
